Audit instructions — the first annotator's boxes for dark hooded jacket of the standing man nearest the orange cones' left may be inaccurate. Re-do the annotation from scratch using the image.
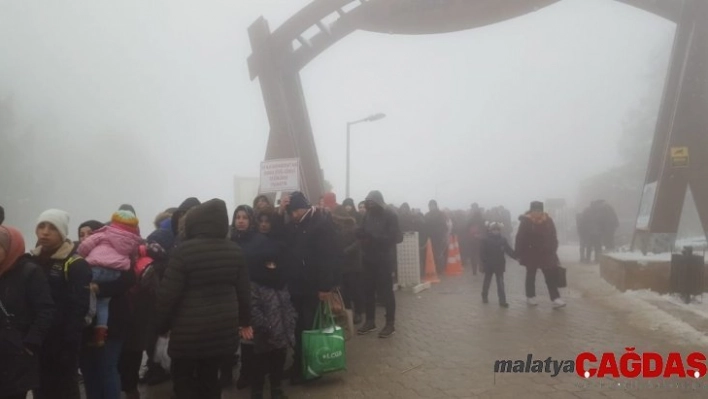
[357,191,403,270]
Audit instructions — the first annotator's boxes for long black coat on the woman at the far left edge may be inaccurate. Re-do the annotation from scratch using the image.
[0,256,54,397]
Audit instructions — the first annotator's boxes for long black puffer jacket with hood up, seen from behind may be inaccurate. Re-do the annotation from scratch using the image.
[156,199,251,359]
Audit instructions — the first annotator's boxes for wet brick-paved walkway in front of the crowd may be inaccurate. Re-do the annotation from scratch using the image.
[146,253,708,399]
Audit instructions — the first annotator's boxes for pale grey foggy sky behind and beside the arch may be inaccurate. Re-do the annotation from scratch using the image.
[0,0,674,233]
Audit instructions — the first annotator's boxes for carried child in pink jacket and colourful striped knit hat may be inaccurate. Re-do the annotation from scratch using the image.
[78,211,142,346]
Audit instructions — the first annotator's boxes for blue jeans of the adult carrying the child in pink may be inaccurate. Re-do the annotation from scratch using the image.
[79,338,123,399]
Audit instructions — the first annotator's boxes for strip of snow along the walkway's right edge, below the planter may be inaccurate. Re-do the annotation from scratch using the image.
[559,247,708,348]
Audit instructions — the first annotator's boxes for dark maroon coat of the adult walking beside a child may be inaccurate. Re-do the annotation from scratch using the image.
[515,212,560,269]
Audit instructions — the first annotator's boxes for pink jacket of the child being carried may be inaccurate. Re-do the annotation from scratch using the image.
[77,225,142,270]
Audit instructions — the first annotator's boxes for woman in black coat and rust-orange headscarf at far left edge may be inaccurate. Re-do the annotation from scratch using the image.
[0,226,54,399]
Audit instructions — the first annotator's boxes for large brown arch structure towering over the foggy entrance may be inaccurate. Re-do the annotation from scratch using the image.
[248,0,708,250]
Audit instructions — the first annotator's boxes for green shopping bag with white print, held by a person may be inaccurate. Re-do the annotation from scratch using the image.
[302,302,347,380]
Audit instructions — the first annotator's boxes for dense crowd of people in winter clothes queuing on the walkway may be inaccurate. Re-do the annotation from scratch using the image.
[0,195,565,399]
